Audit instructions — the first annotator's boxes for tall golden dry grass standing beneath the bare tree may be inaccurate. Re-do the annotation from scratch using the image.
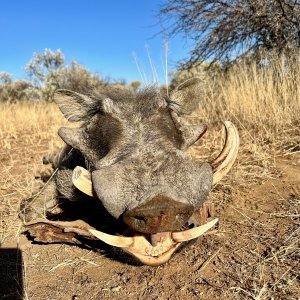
[193,56,300,148]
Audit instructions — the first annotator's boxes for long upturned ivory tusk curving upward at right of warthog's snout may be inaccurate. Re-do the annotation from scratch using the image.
[210,121,240,184]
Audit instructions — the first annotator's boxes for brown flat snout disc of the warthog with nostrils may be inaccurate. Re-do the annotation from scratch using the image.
[123,195,193,233]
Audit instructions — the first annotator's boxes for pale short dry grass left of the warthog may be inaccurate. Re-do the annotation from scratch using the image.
[0,102,65,245]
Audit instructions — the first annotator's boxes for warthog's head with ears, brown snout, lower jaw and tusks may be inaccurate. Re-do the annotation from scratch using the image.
[55,81,238,265]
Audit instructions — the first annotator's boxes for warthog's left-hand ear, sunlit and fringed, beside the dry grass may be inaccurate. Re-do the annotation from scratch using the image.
[54,90,100,122]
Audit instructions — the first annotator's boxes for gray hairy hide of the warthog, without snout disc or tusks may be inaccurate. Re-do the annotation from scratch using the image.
[21,82,212,232]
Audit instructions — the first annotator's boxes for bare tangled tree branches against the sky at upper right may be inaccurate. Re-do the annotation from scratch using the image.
[159,0,300,67]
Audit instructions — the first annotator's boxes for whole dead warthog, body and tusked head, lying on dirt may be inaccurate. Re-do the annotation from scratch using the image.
[20,82,239,265]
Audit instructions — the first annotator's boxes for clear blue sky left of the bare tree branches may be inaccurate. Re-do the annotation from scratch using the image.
[0,0,188,84]
